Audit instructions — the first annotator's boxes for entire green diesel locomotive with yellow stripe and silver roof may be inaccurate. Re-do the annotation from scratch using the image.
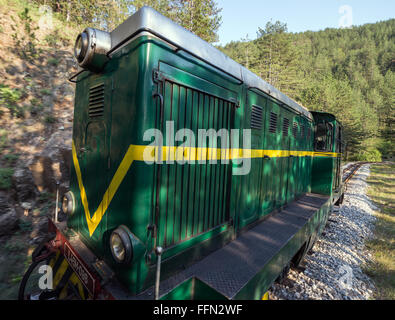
[20,7,343,299]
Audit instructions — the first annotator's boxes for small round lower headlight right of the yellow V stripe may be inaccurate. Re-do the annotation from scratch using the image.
[110,226,133,264]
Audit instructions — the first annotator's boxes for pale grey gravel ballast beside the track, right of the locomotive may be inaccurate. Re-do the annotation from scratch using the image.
[270,165,377,300]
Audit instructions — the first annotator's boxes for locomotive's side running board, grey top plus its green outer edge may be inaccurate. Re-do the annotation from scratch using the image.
[124,194,331,299]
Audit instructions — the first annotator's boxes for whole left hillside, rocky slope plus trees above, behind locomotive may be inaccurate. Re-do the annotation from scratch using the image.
[0,0,224,299]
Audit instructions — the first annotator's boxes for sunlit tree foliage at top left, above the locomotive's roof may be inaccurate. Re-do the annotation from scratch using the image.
[34,0,221,42]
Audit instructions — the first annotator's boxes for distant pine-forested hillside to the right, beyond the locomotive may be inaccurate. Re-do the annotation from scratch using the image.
[219,19,395,160]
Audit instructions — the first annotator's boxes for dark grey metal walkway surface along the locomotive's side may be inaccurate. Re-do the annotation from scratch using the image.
[122,194,329,299]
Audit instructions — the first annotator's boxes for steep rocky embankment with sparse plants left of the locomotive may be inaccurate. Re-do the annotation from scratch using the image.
[0,8,76,241]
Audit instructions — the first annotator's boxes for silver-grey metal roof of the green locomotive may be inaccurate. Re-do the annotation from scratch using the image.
[110,7,312,119]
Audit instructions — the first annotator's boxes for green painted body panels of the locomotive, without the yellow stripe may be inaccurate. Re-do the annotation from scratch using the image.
[68,36,344,298]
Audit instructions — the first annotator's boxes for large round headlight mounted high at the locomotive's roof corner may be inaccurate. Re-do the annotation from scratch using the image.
[74,28,111,72]
